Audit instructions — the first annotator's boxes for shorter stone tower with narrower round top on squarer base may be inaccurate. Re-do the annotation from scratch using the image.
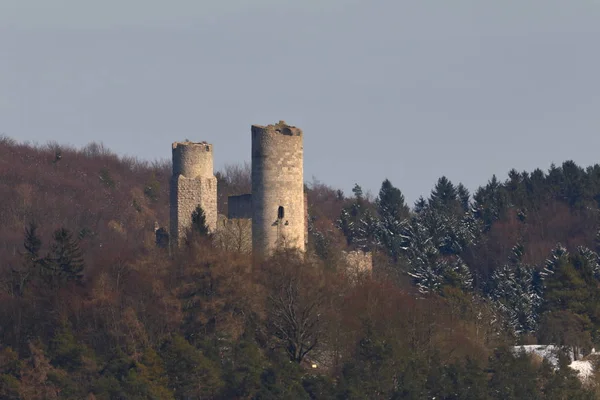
[170,142,217,246]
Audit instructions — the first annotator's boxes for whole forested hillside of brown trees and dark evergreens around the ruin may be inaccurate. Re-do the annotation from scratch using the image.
[0,137,600,399]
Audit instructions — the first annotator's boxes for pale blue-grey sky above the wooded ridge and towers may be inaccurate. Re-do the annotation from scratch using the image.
[0,0,600,203]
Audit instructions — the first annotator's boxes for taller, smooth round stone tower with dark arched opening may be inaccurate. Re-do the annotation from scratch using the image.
[252,121,306,255]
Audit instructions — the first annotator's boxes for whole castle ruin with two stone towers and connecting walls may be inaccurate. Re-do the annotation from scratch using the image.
[170,121,371,270]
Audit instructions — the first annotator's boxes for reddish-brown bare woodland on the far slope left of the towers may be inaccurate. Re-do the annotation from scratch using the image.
[0,141,170,280]
